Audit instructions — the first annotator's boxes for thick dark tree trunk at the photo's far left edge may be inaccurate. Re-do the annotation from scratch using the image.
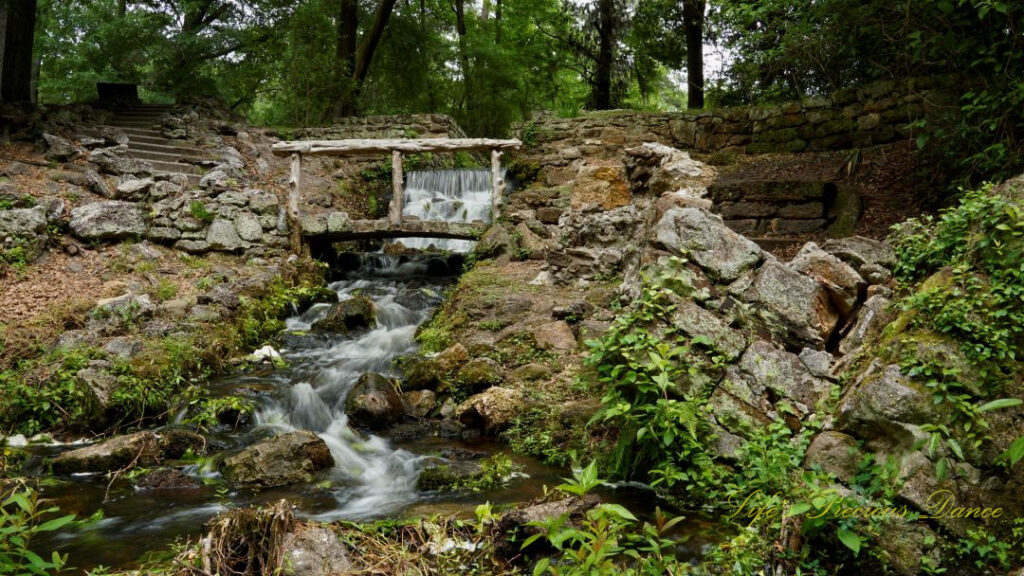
[0,0,36,101]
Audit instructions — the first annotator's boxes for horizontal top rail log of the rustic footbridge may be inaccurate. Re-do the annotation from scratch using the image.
[270,138,522,156]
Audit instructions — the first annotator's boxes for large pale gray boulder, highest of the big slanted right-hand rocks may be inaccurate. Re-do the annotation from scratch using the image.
[651,206,763,282]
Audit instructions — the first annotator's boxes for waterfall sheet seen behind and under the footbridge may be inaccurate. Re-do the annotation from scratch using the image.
[401,168,493,252]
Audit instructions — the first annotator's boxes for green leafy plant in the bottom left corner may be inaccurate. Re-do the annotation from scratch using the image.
[0,485,75,576]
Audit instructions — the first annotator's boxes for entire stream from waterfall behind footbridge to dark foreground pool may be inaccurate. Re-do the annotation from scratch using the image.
[27,170,712,569]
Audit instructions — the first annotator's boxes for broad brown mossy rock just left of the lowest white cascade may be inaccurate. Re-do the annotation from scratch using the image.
[220,430,334,488]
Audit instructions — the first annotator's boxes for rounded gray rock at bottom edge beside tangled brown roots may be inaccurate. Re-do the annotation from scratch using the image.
[281,524,352,576]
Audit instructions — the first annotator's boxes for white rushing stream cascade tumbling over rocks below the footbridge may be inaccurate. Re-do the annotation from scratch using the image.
[256,254,441,520]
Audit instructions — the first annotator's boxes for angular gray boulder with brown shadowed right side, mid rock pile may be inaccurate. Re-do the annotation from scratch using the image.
[743,258,839,347]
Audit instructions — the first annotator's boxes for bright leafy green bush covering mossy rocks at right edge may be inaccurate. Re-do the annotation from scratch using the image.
[891,186,1024,476]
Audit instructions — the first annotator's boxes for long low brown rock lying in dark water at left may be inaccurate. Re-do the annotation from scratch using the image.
[52,431,160,475]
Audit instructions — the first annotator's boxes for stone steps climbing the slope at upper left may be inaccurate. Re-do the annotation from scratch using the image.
[97,105,210,186]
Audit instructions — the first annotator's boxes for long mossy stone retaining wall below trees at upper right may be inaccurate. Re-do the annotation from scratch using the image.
[514,78,955,158]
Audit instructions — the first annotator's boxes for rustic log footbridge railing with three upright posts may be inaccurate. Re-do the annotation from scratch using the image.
[270,138,522,254]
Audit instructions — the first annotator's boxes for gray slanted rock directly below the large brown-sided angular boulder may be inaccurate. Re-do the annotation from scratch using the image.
[739,340,830,410]
